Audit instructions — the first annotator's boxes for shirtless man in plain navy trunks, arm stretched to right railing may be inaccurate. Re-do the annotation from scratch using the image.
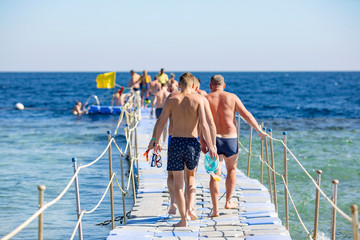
[206,75,269,217]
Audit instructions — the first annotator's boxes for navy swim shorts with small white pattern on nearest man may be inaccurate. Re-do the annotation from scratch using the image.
[167,137,201,171]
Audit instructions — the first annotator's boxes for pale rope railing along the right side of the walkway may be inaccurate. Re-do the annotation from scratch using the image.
[238,115,360,239]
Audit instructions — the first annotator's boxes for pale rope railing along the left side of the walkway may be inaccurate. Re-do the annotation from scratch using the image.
[1,91,140,240]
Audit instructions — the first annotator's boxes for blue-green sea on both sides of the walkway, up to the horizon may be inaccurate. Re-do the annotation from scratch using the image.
[0,72,360,239]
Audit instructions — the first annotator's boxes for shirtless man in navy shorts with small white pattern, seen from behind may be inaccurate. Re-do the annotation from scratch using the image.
[154,73,217,227]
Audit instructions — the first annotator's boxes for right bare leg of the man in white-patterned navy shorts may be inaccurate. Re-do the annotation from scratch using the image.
[185,166,198,220]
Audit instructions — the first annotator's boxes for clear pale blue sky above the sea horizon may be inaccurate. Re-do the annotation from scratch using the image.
[0,0,360,71]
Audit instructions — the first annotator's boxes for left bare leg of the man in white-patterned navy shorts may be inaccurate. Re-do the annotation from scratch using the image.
[172,171,187,227]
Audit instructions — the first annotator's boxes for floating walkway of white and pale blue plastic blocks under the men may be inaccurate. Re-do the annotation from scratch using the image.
[107,110,291,240]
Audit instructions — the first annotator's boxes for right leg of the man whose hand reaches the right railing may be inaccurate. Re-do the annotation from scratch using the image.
[224,153,239,209]
